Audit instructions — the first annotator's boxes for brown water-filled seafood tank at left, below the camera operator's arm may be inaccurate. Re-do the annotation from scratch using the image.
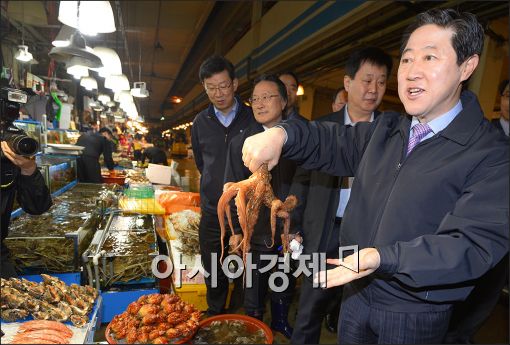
[5,183,116,273]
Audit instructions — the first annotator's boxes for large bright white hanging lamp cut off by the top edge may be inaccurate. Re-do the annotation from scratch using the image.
[58,1,116,36]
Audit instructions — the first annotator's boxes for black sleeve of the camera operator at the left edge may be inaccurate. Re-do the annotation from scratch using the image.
[16,169,52,215]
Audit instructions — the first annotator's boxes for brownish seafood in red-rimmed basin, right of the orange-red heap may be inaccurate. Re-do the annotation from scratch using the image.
[192,320,266,344]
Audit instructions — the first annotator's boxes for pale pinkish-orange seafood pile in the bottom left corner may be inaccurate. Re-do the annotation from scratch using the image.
[9,320,73,344]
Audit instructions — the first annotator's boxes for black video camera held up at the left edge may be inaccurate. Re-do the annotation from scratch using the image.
[0,87,39,158]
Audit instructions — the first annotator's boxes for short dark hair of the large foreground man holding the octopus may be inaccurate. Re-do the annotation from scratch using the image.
[400,8,484,66]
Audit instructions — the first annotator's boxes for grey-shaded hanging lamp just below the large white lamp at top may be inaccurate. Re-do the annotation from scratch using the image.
[48,30,103,68]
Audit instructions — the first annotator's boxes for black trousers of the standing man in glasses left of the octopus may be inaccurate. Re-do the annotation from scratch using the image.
[198,211,236,315]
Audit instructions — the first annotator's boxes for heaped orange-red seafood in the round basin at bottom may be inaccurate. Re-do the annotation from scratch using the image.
[107,294,201,344]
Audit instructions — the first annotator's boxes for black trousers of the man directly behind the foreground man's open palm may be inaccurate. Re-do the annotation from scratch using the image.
[291,219,342,344]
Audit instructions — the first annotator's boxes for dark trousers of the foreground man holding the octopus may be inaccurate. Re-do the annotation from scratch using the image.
[337,284,452,344]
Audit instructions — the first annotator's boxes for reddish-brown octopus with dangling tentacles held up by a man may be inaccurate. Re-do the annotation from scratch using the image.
[218,164,297,263]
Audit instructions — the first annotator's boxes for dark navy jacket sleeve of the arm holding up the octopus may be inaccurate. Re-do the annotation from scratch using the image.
[279,117,374,176]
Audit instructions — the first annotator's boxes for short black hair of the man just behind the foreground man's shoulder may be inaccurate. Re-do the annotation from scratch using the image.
[345,47,393,79]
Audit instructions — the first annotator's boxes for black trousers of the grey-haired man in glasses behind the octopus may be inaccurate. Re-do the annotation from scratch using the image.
[244,245,296,315]
